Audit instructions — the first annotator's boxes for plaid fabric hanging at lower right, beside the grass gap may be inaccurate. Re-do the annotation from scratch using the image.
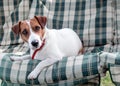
[100,52,120,86]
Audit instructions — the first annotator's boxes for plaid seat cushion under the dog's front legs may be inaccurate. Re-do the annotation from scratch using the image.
[0,54,99,86]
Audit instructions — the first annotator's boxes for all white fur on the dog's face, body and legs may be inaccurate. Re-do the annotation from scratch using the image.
[11,22,82,79]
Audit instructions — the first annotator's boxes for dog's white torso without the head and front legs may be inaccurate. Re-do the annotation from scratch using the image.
[32,28,82,60]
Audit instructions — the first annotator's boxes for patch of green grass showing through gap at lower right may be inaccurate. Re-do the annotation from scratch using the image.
[101,72,115,86]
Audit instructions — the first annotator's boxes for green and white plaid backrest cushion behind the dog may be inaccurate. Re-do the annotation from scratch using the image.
[0,0,113,47]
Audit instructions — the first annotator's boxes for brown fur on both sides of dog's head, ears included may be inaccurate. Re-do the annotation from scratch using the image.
[12,16,47,42]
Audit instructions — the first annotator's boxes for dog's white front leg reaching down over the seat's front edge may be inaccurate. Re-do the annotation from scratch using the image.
[28,58,59,79]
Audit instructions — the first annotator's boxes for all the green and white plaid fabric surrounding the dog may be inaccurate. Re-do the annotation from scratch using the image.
[0,0,120,86]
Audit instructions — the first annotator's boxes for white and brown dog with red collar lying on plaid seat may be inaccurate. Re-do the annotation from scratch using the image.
[10,16,83,79]
